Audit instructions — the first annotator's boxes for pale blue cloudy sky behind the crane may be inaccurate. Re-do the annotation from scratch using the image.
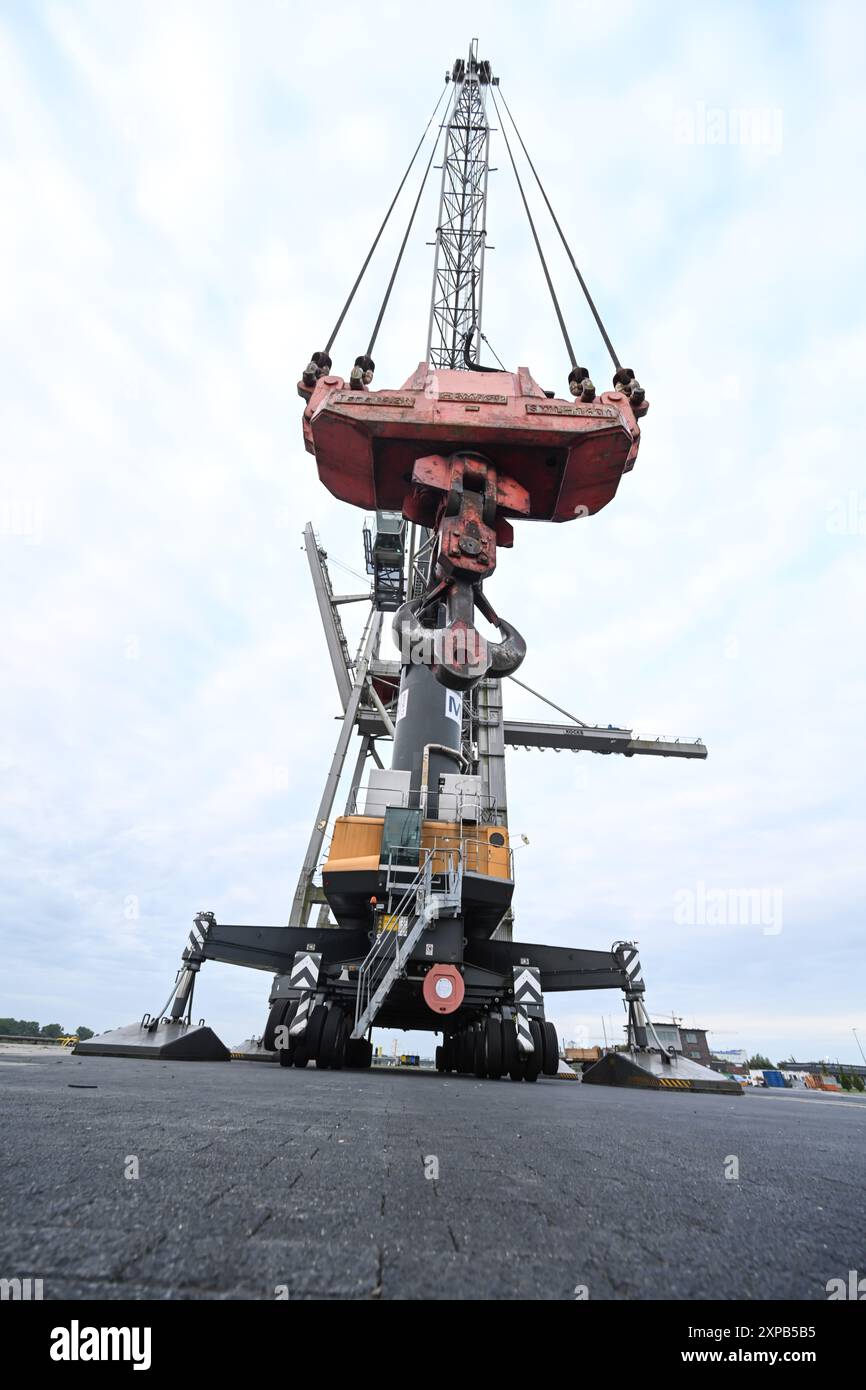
[0,0,866,1059]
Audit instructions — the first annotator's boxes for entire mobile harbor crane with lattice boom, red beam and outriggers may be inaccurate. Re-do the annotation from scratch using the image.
[76,40,740,1091]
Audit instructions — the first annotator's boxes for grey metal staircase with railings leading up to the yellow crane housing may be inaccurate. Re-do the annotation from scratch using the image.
[352,845,463,1038]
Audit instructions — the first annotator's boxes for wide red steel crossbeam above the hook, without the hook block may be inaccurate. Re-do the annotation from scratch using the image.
[299,363,645,528]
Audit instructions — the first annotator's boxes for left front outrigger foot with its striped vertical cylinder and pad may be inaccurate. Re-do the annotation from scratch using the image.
[72,912,231,1062]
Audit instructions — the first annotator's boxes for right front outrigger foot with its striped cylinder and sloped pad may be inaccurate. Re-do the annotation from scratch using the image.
[584,941,744,1095]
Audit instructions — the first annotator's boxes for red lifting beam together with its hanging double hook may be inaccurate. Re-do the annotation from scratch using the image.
[297,363,648,688]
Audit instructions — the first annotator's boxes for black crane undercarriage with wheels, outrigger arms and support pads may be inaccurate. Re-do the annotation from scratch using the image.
[75,913,740,1093]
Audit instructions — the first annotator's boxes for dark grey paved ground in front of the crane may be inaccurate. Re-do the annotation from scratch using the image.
[0,1047,866,1300]
